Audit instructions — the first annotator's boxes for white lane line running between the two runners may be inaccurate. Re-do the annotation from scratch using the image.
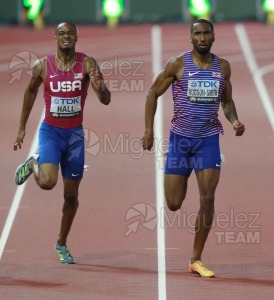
[151,26,166,300]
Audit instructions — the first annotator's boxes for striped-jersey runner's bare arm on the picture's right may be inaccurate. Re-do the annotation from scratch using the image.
[220,59,245,136]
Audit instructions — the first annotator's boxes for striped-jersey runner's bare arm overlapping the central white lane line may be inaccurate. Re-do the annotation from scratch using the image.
[142,56,184,150]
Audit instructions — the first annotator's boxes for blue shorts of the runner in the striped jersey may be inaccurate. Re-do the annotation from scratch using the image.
[165,131,221,176]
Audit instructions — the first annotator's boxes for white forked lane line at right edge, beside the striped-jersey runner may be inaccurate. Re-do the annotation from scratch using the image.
[235,24,274,131]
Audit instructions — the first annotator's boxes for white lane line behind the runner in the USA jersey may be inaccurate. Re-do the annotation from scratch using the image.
[0,111,45,261]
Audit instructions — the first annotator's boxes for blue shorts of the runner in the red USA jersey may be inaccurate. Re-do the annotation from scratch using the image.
[38,121,85,180]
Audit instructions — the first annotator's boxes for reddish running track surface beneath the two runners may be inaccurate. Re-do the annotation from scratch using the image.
[0,23,274,300]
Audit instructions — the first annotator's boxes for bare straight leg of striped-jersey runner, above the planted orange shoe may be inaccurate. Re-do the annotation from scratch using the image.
[191,169,220,263]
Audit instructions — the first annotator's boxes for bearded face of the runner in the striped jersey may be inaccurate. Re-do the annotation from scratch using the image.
[190,23,215,55]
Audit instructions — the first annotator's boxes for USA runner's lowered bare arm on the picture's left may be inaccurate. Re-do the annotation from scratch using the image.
[13,59,44,150]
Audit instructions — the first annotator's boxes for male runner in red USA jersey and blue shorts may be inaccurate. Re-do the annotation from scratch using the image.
[14,23,111,264]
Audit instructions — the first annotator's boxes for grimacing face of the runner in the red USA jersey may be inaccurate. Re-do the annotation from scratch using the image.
[55,23,78,50]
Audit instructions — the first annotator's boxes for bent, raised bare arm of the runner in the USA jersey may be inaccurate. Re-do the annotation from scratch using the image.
[85,57,111,105]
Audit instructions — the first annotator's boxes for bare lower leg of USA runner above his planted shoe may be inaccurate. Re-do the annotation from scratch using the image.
[57,178,81,246]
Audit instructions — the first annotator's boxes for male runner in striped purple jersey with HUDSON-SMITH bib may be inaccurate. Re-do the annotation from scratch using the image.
[142,19,245,277]
